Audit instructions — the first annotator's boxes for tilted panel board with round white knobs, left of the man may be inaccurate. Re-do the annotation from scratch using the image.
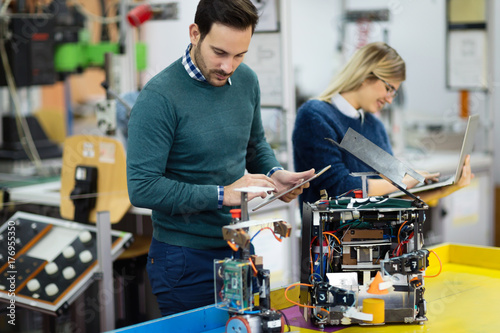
[0,212,132,315]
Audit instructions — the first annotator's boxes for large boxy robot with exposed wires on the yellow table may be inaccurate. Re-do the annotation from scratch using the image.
[300,197,429,327]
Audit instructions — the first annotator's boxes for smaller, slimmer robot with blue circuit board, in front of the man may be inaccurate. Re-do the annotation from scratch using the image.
[214,188,291,333]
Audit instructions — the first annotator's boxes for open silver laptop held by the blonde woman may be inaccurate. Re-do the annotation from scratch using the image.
[389,114,479,197]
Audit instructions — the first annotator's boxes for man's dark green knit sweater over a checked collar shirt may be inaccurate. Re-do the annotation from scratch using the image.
[127,59,279,249]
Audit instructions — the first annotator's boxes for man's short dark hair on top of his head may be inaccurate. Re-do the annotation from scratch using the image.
[194,0,259,40]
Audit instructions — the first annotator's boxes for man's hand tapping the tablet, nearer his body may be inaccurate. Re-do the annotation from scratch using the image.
[222,172,277,206]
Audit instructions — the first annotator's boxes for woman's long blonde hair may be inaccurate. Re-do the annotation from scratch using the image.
[317,42,406,102]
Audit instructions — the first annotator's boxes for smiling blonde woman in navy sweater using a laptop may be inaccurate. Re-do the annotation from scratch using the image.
[292,42,474,202]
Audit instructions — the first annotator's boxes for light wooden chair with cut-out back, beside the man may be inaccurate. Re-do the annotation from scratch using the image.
[60,135,152,323]
